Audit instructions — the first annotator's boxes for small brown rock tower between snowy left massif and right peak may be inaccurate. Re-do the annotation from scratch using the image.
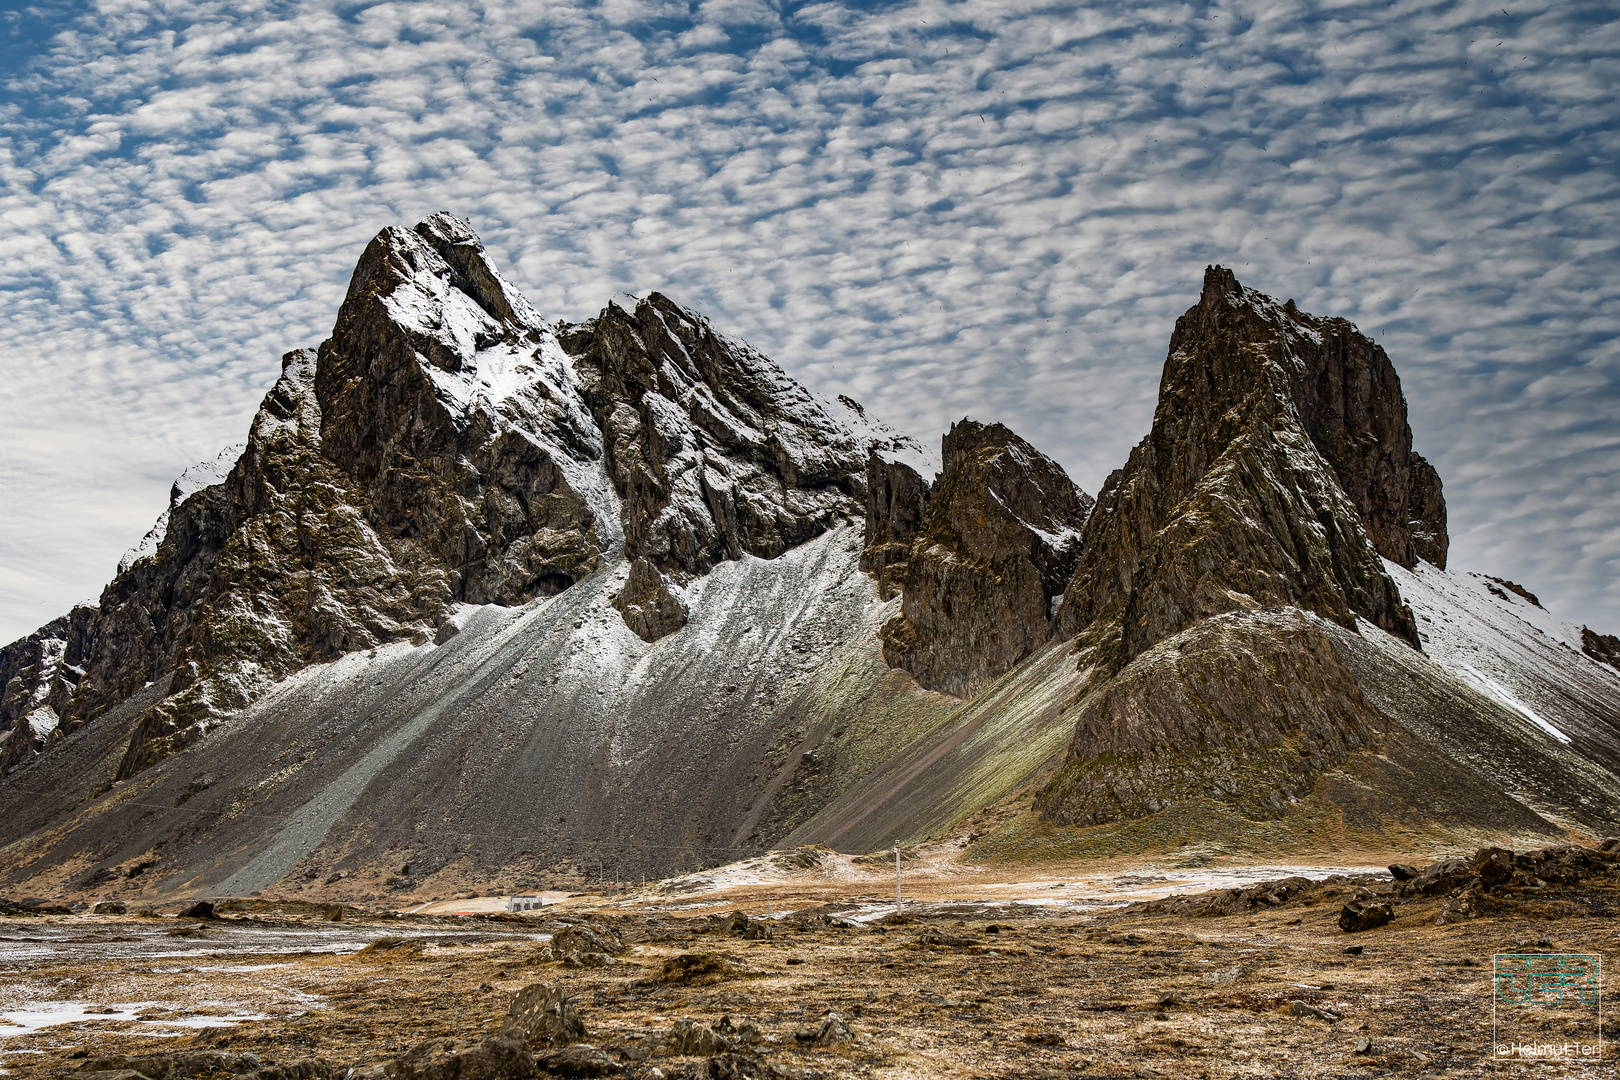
[881,419,1092,696]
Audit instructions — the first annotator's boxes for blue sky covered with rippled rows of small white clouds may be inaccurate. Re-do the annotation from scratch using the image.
[0,0,1620,641]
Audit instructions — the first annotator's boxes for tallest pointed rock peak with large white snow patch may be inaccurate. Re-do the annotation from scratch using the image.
[316,214,601,604]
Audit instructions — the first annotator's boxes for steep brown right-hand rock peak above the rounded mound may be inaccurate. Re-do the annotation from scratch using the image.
[1058,267,1425,670]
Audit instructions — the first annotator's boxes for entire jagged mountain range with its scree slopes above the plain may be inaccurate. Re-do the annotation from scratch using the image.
[0,228,1620,913]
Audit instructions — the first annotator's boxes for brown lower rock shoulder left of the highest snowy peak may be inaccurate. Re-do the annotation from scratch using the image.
[99,350,452,776]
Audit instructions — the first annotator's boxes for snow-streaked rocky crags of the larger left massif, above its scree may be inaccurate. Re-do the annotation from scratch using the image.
[8,212,914,786]
